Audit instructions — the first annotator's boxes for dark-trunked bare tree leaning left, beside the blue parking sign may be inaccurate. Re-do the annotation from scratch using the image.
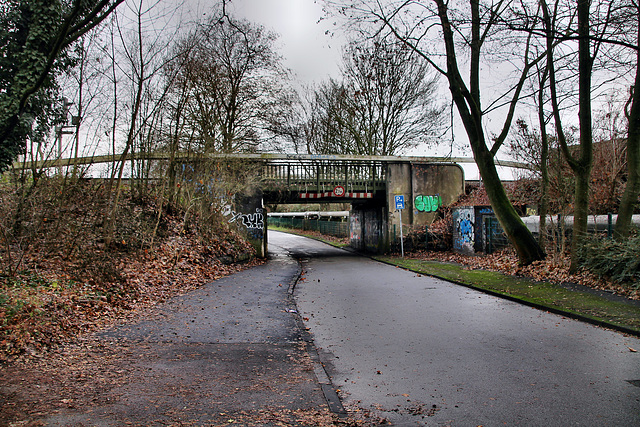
[328,0,545,264]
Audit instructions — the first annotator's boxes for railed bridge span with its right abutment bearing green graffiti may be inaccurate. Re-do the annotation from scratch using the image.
[248,155,464,260]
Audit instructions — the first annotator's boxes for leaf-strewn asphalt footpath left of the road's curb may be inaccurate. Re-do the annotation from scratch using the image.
[40,237,329,427]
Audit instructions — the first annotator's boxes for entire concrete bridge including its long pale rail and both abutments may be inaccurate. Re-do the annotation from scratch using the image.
[14,153,527,257]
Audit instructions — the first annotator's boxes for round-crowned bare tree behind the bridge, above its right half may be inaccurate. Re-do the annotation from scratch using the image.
[316,37,443,156]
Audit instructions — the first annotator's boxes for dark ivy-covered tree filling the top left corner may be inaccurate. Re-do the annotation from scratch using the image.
[0,0,124,172]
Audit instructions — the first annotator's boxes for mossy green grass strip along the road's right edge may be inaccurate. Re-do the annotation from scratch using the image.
[373,256,640,336]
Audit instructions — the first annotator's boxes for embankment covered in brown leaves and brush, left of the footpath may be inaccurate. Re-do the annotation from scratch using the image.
[0,177,255,361]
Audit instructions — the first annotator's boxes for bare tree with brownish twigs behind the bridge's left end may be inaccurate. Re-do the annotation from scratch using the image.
[175,14,284,153]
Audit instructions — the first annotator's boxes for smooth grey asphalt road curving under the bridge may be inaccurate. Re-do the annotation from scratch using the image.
[269,232,640,426]
